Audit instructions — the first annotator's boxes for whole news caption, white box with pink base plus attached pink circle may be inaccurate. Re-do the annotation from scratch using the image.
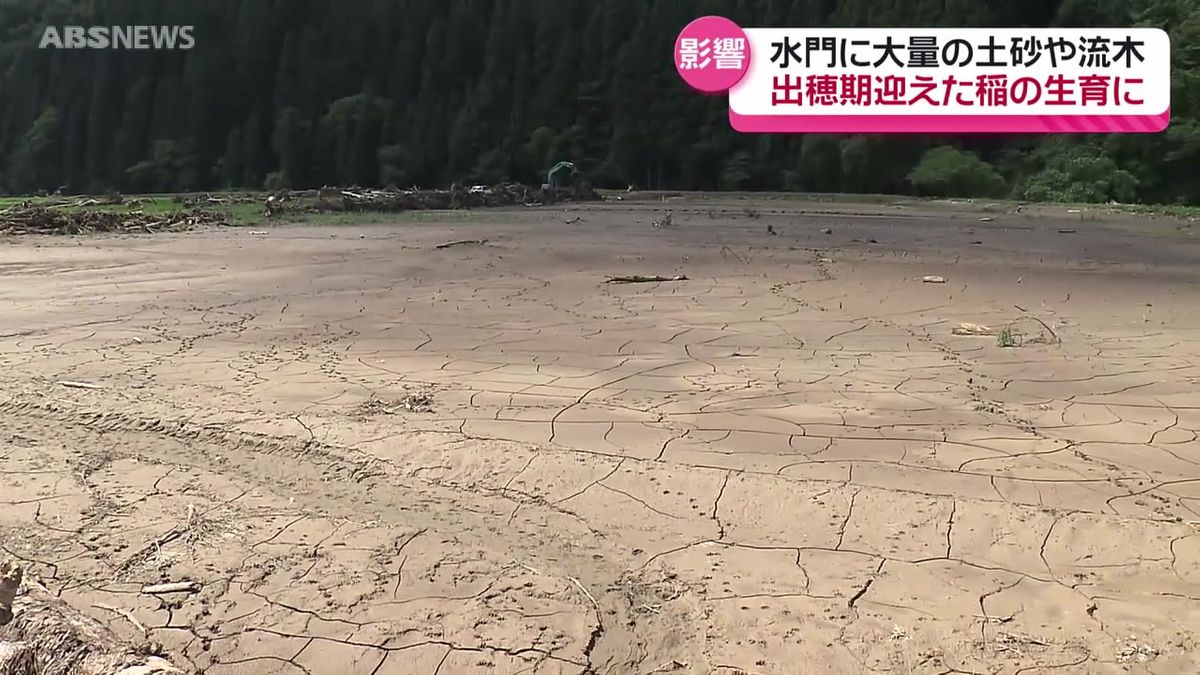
[674,17,1171,133]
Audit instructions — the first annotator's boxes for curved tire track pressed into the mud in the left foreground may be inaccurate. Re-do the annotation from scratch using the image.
[0,400,682,673]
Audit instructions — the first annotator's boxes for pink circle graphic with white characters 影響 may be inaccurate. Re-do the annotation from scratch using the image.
[674,17,750,94]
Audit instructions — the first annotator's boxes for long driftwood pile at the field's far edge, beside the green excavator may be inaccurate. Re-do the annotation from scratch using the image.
[266,183,602,216]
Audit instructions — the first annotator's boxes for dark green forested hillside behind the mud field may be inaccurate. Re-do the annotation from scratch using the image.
[0,0,1200,204]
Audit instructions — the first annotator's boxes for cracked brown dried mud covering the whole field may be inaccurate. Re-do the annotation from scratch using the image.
[0,198,1200,675]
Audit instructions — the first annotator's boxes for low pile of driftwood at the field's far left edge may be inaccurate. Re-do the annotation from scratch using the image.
[0,202,228,234]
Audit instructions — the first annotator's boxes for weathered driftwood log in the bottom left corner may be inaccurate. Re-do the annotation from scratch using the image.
[0,562,184,675]
